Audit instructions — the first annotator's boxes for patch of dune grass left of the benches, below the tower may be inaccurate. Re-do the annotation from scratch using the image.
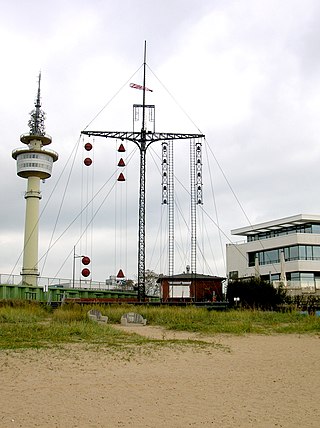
[0,304,151,349]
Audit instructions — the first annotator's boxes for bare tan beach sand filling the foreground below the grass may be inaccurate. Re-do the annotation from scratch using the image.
[0,326,320,428]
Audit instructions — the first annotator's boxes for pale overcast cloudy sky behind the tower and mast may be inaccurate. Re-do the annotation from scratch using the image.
[0,0,320,281]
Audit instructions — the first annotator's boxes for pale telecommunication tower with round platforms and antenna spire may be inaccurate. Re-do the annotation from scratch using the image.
[12,73,58,286]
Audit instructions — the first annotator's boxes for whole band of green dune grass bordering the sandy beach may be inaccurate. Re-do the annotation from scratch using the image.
[0,304,320,350]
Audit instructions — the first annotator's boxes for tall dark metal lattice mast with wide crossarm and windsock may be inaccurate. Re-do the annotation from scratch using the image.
[82,42,204,301]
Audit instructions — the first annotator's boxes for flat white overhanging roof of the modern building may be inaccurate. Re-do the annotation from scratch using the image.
[231,214,320,236]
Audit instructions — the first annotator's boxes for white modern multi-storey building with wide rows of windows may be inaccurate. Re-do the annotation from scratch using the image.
[226,214,320,294]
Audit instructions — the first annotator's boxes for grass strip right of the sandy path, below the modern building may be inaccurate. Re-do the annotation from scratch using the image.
[101,306,320,334]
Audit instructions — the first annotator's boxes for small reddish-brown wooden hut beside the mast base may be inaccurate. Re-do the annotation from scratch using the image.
[157,272,225,303]
